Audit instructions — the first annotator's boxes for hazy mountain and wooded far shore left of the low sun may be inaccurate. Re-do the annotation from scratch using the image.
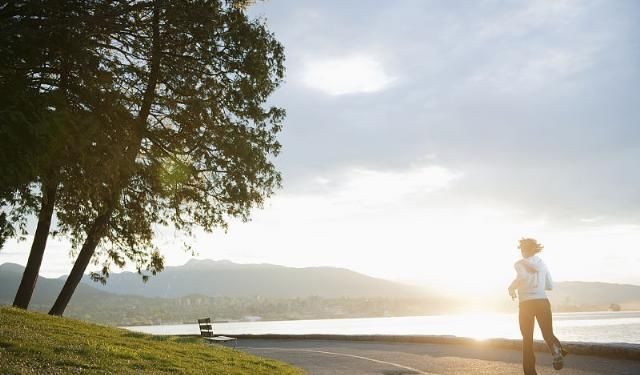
[0,261,452,325]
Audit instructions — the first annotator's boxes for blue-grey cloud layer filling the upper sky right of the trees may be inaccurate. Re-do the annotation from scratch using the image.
[255,1,640,226]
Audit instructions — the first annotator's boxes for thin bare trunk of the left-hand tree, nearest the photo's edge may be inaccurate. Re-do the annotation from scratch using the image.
[13,180,58,309]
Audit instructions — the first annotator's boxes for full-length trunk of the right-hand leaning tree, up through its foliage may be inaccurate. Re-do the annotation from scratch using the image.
[49,0,162,316]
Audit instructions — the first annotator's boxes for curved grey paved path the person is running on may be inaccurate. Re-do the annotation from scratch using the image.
[238,339,640,375]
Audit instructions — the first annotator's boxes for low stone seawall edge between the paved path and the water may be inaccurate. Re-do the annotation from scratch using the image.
[219,333,640,361]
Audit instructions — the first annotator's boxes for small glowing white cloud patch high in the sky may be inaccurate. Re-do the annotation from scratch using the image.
[302,55,394,96]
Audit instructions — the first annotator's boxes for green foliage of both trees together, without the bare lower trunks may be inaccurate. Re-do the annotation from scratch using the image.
[0,0,284,290]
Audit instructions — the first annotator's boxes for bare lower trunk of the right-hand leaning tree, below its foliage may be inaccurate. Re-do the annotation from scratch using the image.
[49,210,113,316]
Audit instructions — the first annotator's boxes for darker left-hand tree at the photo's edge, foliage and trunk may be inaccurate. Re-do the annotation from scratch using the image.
[0,0,134,308]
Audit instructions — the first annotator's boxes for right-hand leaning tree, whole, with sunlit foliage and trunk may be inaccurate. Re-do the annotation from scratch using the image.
[50,0,284,315]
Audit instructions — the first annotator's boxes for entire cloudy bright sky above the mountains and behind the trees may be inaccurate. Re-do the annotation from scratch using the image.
[0,0,640,295]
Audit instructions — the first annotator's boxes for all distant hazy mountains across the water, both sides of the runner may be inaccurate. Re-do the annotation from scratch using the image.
[0,260,640,324]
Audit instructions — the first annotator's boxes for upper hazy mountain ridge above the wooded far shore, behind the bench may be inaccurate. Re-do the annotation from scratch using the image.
[79,260,431,298]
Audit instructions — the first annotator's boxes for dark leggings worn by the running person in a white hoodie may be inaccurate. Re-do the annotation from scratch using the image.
[518,298,560,375]
